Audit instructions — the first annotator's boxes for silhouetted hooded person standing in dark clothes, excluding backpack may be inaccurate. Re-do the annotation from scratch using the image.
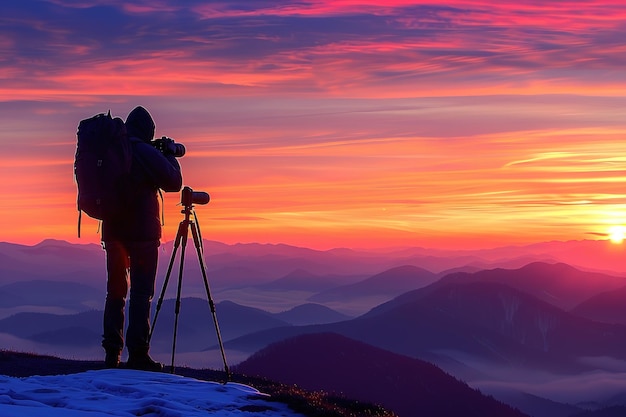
[102,106,182,371]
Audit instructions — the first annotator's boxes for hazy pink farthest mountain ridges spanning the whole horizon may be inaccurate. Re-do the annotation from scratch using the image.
[0,239,626,288]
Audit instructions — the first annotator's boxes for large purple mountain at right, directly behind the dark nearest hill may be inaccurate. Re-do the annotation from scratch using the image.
[230,264,626,372]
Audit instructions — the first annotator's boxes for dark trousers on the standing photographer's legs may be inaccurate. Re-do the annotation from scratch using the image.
[102,241,159,352]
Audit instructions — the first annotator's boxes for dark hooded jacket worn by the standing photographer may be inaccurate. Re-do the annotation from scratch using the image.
[102,106,183,242]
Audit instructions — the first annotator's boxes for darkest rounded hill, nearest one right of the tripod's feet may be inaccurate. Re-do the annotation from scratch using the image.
[235,333,526,417]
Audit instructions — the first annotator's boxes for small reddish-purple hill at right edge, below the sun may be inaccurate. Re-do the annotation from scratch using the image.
[571,287,626,325]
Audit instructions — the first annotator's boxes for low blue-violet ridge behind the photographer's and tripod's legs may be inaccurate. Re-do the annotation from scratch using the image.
[0,297,349,352]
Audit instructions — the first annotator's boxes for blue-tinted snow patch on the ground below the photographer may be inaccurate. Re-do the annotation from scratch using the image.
[0,369,301,417]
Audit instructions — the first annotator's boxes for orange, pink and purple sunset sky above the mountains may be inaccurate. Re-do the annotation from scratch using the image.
[0,0,626,249]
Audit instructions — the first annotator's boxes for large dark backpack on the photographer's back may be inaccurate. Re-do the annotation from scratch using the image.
[74,110,132,237]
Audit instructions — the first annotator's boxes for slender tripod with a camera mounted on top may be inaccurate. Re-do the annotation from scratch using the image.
[148,187,231,381]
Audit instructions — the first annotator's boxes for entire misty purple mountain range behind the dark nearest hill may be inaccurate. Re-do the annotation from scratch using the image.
[0,241,626,417]
